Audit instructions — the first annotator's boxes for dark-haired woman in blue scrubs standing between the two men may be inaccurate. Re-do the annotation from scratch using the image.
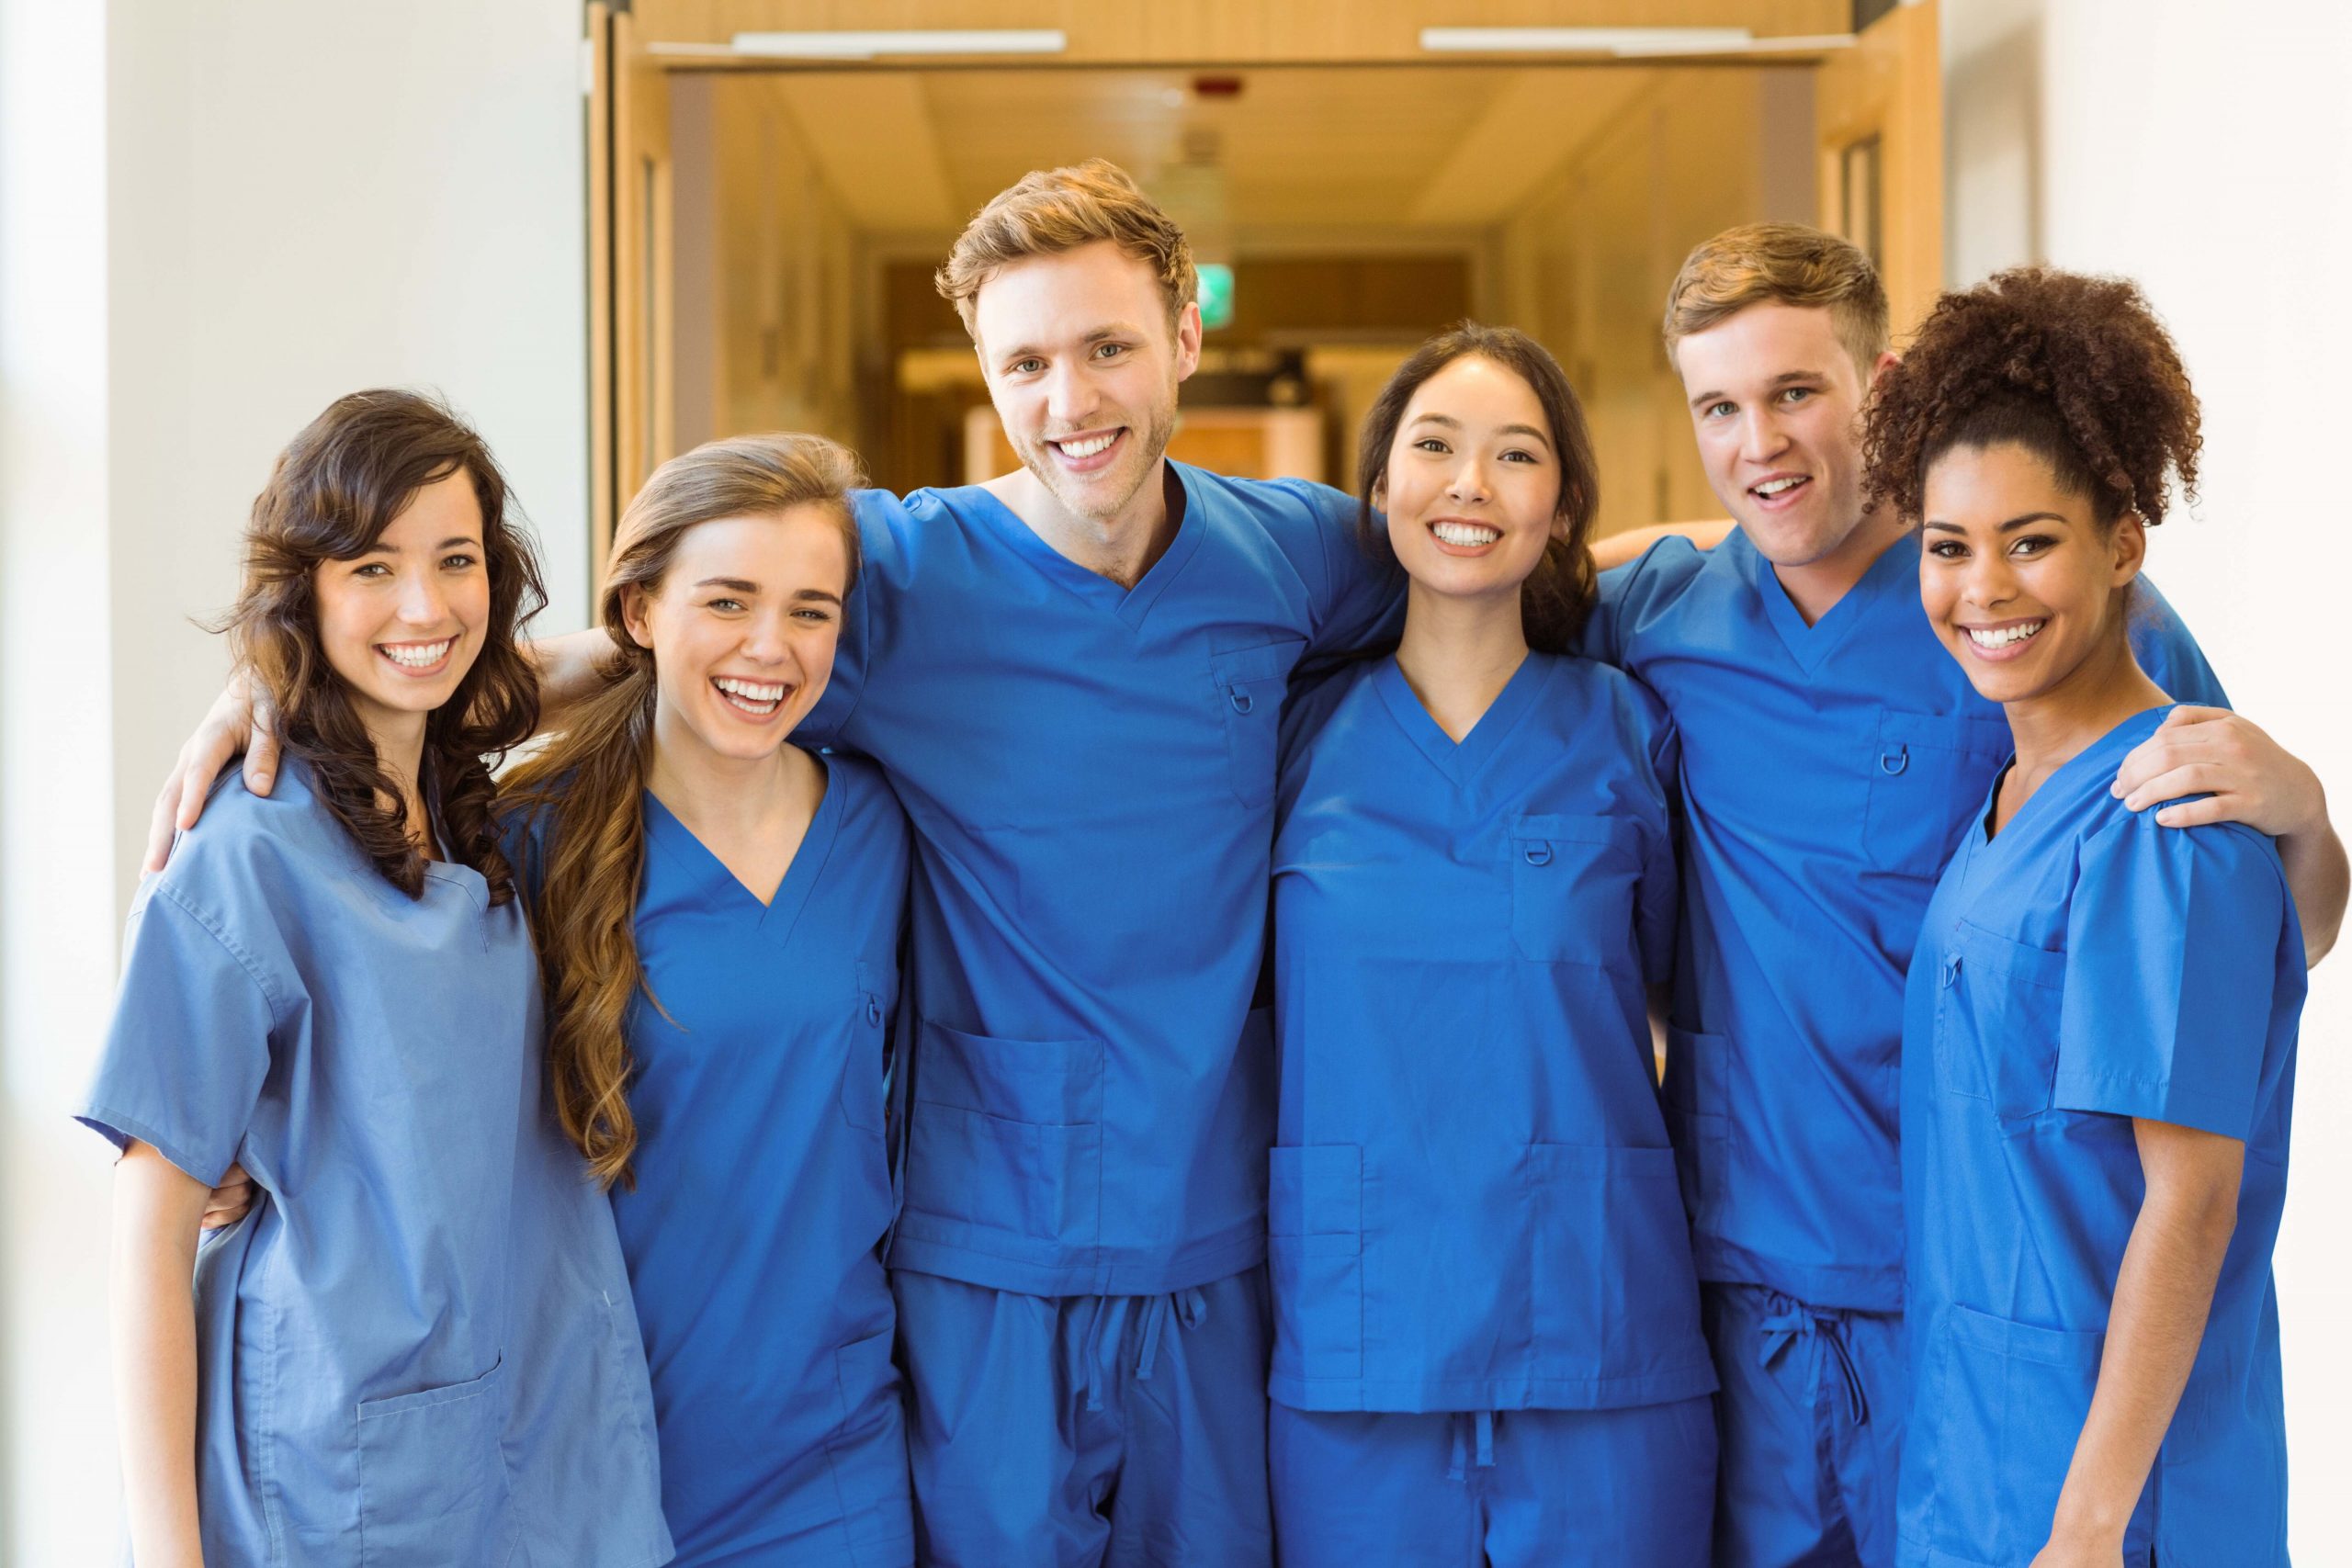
[1268,324,1714,1568]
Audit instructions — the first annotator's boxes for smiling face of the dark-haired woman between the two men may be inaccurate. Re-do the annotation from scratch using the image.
[1374,355,1562,602]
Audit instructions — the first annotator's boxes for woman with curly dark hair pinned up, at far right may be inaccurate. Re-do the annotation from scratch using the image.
[1868,268,2305,1568]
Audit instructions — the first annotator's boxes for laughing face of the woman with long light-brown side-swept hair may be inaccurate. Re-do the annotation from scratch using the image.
[623,505,849,761]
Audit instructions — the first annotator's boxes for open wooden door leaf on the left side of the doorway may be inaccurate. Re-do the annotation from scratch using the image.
[588,0,677,581]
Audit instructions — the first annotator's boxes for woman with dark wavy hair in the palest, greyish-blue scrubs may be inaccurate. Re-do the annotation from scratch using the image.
[80,390,668,1568]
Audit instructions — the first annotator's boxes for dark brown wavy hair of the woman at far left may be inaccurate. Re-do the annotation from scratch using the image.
[221,390,548,905]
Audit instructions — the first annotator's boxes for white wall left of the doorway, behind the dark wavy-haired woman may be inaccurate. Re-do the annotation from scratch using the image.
[0,0,588,1568]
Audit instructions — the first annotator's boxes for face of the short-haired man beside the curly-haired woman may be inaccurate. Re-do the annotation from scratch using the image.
[1675,301,1894,567]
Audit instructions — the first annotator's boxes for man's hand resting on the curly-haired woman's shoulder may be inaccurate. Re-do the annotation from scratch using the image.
[2114,707,2328,840]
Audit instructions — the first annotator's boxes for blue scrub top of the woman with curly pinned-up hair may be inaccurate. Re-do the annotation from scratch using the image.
[1900,707,2305,1565]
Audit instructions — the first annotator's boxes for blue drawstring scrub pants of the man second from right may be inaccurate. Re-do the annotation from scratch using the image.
[1698,1283,1910,1568]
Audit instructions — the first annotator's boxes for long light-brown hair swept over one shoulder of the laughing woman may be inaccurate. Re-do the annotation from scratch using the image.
[505,434,865,1187]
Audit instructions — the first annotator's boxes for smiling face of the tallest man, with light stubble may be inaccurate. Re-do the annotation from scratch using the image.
[971,240,1200,522]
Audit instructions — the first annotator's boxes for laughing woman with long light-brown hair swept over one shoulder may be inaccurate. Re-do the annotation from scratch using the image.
[511,434,912,1568]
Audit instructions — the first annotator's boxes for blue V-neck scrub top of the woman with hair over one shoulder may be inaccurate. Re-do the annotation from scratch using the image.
[517,757,912,1568]
